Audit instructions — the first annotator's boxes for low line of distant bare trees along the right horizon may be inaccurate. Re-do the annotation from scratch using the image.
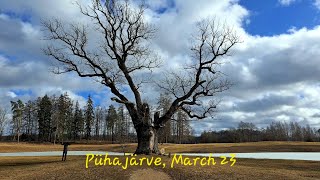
[199,121,320,143]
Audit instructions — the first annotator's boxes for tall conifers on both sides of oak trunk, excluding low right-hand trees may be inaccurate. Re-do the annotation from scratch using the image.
[0,93,192,143]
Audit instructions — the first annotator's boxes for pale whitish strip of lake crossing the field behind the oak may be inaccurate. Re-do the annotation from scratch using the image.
[0,151,320,161]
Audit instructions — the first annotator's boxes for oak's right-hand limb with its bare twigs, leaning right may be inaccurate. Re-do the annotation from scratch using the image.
[159,20,240,124]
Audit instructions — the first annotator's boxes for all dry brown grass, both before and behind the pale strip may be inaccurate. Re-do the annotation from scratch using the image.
[0,142,320,180]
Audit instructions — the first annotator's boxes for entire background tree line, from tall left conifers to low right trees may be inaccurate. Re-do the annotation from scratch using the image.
[0,93,320,143]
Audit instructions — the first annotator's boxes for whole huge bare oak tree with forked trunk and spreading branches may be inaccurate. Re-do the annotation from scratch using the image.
[43,0,239,154]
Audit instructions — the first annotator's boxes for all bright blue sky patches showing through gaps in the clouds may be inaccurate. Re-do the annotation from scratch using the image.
[0,0,320,101]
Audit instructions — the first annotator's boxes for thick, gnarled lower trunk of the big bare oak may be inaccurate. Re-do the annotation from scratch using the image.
[135,125,160,154]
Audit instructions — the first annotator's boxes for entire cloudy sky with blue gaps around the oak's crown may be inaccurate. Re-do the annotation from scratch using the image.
[0,0,320,134]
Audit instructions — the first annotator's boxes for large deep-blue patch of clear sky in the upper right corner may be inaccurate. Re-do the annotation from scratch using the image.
[239,0,320,36]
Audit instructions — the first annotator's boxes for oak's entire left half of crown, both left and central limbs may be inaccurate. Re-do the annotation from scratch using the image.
[43,0,159,124]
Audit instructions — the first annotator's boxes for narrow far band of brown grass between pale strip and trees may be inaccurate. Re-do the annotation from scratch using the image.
[0,142,320,153]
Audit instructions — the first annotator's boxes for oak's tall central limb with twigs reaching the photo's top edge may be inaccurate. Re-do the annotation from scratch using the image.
[75,0,159,110]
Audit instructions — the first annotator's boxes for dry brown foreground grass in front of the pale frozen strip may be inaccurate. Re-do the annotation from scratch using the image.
[0,156,320,180]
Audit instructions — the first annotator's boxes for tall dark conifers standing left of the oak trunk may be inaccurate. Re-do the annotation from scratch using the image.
[4,93,134,143]
